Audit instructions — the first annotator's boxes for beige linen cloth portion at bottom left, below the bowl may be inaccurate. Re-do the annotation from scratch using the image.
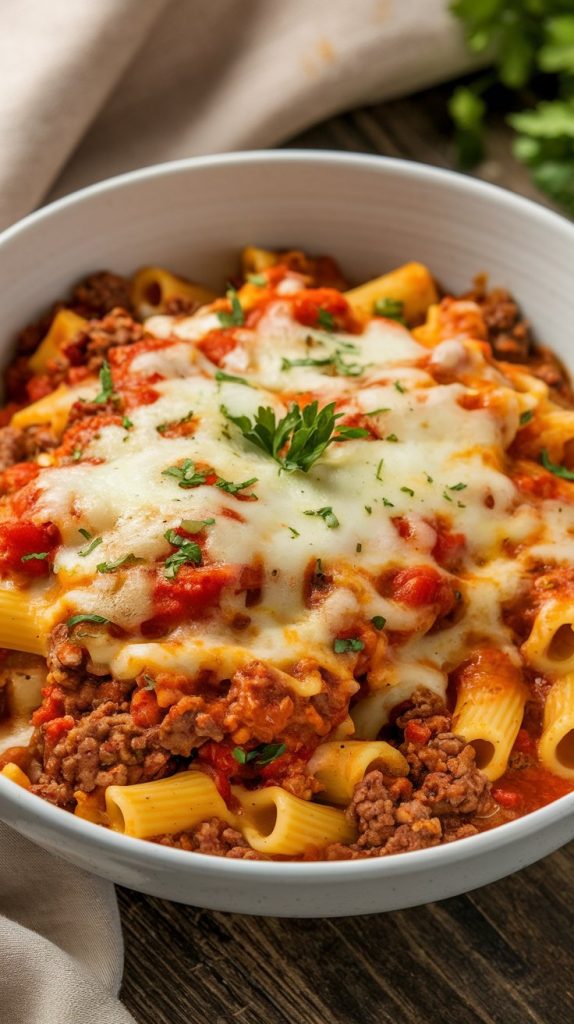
[0,822,133,1024]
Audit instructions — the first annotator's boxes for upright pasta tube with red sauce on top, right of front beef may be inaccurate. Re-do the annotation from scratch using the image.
[452,658,528,780]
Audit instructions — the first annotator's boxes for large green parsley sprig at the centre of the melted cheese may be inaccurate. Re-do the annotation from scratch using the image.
[222,401,368,473]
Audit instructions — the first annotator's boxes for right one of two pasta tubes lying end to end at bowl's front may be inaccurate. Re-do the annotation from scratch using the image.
[234,785,354,856]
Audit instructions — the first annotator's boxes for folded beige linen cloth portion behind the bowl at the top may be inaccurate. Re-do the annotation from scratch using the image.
[0,0,478,226]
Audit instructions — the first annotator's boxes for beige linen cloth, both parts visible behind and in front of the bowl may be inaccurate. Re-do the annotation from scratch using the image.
[0,0,478,1024]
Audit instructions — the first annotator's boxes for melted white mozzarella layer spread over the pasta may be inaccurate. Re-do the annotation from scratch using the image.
[24,288,574,714]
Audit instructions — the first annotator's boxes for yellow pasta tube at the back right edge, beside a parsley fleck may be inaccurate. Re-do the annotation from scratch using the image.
[346,263,437,324]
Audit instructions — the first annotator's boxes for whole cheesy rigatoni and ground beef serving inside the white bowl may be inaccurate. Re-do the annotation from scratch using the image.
[0,248,574,860]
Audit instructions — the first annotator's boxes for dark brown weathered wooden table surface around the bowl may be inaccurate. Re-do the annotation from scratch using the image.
[118,81,574,1024]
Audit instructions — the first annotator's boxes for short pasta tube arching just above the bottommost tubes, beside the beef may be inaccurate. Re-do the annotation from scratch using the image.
[309,739,408,806]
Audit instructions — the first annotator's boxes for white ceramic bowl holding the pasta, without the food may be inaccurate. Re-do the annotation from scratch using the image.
[0,151,574,918]
